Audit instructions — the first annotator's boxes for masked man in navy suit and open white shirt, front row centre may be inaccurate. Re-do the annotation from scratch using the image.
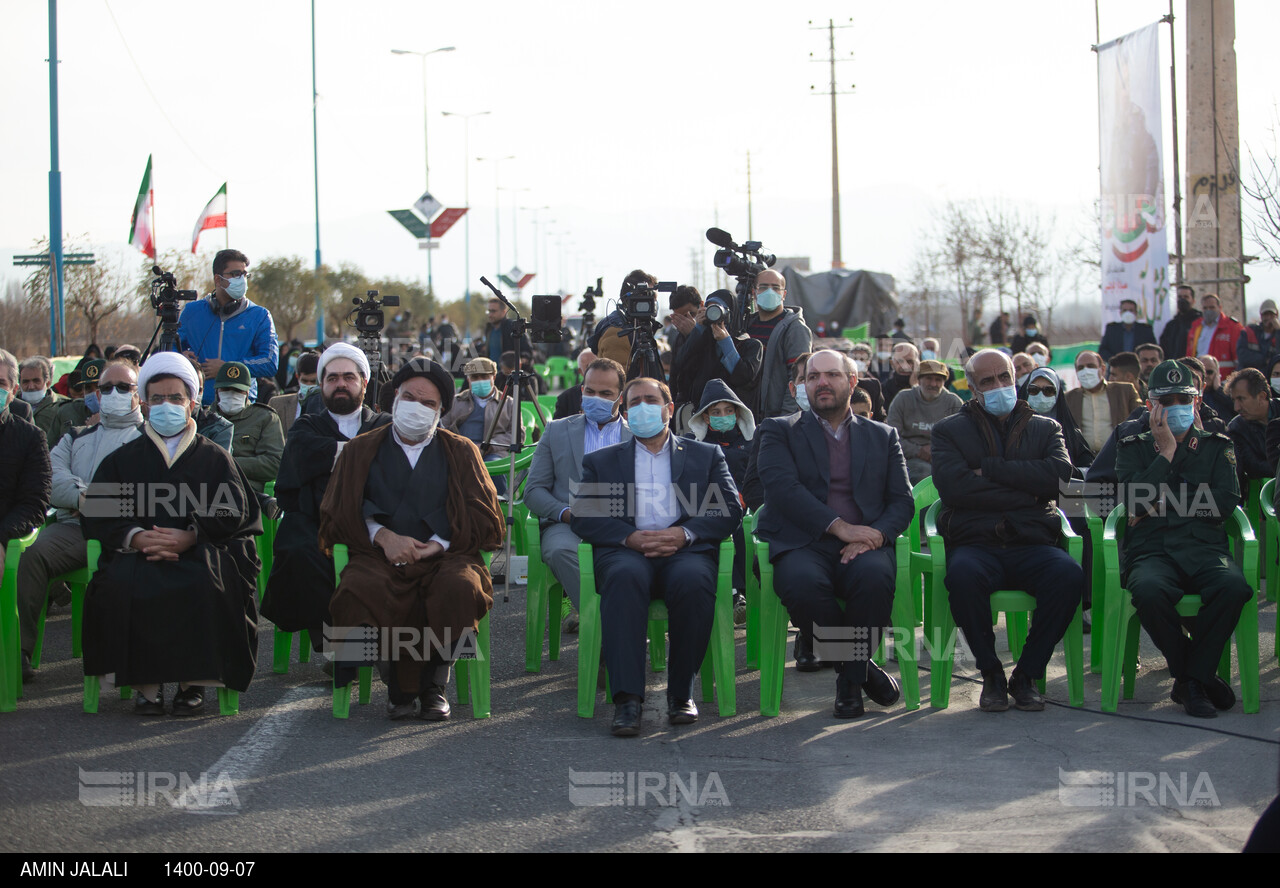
[570,376,742,737]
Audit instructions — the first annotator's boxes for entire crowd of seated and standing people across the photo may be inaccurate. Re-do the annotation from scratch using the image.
[0,250,1280,767]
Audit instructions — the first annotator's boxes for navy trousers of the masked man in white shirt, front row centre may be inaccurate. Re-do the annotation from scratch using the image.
[595,546,718,700]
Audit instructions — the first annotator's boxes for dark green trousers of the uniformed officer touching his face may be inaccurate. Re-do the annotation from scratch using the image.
[1126,554,1253,682]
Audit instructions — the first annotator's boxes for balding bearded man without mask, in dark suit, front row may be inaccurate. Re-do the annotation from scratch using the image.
[756,349,915,718]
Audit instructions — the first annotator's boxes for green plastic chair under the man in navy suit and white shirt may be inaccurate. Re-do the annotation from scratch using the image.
[577,539,737,718]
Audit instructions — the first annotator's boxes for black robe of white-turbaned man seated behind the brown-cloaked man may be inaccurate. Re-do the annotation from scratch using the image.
[254,407,392,637]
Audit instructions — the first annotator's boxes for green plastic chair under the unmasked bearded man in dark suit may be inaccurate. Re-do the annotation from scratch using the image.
[755,536,920,717]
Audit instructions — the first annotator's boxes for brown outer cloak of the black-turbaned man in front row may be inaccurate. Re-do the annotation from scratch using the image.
[320,424,507,694]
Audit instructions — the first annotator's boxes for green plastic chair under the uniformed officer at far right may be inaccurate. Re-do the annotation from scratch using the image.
[1102,505,1261,713]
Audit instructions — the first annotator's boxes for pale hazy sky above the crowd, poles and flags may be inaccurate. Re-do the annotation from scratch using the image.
[0,0,1280,319]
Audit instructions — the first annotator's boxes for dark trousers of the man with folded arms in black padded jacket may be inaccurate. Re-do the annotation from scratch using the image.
[942,546,1084,678]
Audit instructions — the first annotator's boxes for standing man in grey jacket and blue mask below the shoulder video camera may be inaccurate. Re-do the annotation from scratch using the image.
[746,269,813,420]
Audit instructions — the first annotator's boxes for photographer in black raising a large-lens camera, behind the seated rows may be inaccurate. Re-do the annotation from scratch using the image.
[671,288,764,429]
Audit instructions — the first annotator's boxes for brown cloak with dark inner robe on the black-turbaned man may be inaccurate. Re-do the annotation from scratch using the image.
[320,426,506,694]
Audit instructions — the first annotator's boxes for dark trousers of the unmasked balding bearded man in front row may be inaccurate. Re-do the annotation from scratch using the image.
[773,535,897,685]
